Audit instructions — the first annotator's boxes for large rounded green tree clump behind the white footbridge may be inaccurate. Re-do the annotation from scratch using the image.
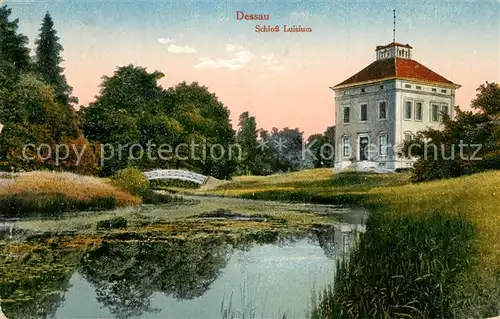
[80,65,236,178]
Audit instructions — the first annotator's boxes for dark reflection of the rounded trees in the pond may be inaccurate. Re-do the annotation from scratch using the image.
[80,238,231,318]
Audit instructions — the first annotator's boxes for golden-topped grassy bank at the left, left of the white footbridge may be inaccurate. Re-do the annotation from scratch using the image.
[0,172,141,216]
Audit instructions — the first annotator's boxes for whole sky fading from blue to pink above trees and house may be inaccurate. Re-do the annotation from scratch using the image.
[4,0,500,136]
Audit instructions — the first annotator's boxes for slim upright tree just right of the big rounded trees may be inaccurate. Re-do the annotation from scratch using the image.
[236,112,258,174]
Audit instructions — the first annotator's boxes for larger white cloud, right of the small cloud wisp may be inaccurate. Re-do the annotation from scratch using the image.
[194,44,255,71]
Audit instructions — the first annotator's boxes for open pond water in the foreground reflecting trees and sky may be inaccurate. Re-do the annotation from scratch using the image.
[0,224,363,319]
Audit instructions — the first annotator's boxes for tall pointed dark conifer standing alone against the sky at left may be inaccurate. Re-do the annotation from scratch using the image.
[35,12,78,105]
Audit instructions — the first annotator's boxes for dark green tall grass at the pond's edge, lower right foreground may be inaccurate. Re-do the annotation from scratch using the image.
[312,212,477,318]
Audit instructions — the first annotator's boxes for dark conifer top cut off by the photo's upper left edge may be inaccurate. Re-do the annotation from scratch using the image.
[0,5,30,71]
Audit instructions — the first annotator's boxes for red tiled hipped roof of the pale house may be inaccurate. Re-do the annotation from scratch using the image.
[335,58,456,87]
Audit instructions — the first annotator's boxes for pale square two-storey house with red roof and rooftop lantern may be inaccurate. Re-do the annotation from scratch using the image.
[331,42,460,170]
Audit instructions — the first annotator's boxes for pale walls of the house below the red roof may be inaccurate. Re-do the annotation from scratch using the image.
[335,79,455,169]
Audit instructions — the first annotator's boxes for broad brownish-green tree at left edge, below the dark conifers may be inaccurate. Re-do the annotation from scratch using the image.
[0,74,79,170]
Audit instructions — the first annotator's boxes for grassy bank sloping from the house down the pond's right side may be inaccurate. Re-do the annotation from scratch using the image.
[197,170,500,318]
